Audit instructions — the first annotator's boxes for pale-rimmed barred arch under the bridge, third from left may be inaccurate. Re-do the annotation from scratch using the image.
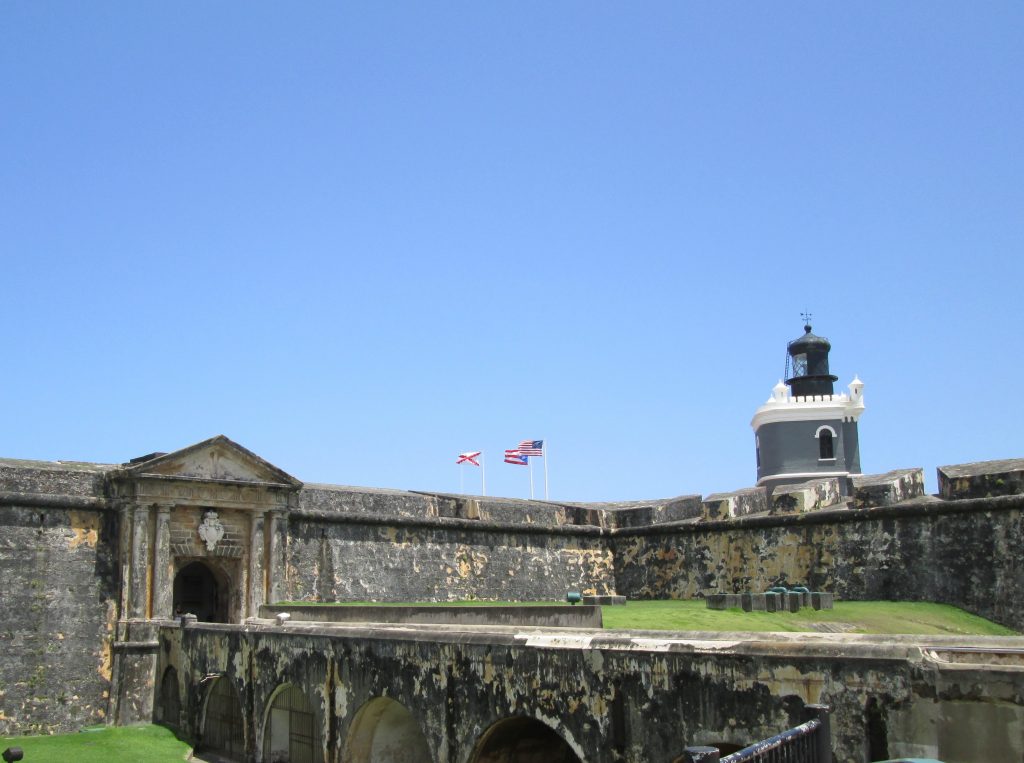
[261,683,324,763]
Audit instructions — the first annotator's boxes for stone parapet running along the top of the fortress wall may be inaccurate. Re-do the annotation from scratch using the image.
[0,452,1024,534]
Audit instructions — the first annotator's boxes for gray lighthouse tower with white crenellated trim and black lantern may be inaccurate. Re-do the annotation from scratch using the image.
[751,324,864,495]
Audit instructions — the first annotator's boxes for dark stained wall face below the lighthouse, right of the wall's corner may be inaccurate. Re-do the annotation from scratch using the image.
[612,496,1024,630]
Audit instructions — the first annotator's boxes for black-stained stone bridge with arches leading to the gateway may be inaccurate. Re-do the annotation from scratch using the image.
[159,623,1024,763]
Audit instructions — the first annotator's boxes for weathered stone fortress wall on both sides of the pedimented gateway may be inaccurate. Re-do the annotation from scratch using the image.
[0,444,1024,745]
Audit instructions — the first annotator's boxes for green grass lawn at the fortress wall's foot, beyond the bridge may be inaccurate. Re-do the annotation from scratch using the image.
[289,599,1019,636]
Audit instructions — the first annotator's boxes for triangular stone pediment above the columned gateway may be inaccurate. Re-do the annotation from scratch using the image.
[124,434,302,488]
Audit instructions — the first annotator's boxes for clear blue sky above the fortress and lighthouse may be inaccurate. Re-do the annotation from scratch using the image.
[0,0,1024,501]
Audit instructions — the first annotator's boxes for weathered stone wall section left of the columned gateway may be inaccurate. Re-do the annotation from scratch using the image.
[0,462,119,733]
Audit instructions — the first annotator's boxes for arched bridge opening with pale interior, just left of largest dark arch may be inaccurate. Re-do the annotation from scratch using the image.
[341,696,433,763]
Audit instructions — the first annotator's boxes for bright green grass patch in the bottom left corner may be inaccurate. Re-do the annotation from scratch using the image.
[0,725,191,763]
